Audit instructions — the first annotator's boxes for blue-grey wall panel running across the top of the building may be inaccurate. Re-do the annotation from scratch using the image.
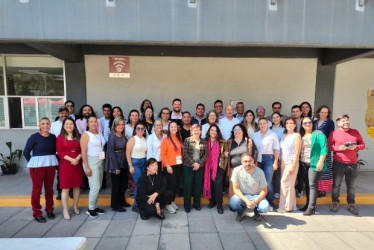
[0,0,374,48]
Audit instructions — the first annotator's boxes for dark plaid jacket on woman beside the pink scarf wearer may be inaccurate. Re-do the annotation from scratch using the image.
[183,136,208,167]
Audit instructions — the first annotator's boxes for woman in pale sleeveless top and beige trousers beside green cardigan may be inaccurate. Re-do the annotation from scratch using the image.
[278,117,301,212]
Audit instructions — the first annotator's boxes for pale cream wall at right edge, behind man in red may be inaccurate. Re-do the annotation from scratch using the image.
[333,59,374,170]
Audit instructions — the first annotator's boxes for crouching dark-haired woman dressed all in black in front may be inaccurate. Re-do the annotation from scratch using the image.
[136,158,172,220]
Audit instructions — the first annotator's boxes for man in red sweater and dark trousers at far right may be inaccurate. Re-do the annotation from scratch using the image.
[328,115,365,215]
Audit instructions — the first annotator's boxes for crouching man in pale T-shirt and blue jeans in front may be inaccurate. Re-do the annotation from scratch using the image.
[229,153,270,222]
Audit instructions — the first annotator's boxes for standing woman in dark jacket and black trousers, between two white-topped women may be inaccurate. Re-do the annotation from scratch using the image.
[105,117,127,212]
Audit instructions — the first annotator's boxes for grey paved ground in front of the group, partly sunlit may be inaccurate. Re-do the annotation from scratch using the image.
[0,205,374,250]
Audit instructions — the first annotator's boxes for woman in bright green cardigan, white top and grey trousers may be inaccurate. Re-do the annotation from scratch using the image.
[299,117,328,215]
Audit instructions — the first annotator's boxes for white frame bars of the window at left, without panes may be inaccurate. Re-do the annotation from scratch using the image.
[0,54,66,130]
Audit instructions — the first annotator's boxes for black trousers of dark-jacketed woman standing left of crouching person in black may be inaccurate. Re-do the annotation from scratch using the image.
[110,169,126,209]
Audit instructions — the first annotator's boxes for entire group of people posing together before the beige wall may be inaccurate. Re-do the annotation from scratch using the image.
[24,98,365,223]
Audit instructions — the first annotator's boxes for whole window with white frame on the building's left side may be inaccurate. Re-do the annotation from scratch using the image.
[0,56,65,128]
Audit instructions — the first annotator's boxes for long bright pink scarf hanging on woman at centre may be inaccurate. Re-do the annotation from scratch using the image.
[203,141,220,199]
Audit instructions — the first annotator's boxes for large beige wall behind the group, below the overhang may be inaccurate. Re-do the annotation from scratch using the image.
[85,55,317,118]
